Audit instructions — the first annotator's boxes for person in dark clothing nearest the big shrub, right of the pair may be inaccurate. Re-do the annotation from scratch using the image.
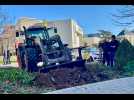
[110,35,119,67]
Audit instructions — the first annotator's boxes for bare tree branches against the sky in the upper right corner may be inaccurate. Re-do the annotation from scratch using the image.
[112,5,134,26]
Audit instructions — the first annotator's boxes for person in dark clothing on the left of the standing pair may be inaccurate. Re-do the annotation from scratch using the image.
[100,39,110,66]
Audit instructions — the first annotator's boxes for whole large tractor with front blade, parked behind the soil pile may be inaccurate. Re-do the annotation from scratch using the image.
[16,26,85,73]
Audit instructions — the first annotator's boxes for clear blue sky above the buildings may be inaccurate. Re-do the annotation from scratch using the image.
[2,5,131,34]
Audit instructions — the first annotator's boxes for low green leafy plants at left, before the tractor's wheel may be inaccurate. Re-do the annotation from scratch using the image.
[0,68,34,84]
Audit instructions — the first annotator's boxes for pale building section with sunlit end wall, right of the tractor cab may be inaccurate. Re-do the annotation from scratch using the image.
[47,19,84,48]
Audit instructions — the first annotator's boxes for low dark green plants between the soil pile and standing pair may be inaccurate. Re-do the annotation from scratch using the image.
[86,62,119,81]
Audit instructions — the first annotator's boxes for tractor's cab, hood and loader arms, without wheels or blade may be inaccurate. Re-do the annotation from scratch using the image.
[21,26,71,69]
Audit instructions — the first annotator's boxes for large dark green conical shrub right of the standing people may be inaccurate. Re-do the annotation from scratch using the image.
[115,39,134,70]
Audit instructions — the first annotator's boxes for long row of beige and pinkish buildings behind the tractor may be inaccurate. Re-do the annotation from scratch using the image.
[0,17,83,54]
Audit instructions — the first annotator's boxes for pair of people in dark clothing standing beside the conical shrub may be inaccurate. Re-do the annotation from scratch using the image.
[99,35,119,67]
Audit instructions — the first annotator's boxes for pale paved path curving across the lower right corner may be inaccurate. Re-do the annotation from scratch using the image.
[44,77,134,94]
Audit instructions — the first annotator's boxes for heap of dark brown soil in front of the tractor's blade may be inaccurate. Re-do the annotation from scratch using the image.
[34,67,98,89]
